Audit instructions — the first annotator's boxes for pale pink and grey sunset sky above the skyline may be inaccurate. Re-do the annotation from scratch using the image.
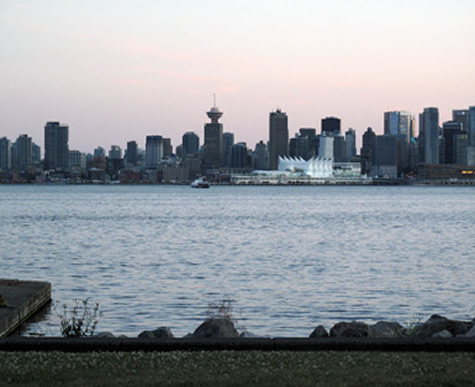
[0,0,475,152]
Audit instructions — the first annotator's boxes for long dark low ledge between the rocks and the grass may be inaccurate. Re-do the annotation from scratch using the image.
[0,337,475,352]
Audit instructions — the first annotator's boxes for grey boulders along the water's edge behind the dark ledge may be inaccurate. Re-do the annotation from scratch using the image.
[94,314,475,339]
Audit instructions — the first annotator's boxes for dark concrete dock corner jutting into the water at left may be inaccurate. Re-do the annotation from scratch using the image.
[0,279,51,338]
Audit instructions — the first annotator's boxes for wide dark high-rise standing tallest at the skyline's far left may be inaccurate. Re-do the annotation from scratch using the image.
[44,122,69,171]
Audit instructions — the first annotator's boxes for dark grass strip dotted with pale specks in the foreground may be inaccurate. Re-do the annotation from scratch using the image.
[0,351,475,386]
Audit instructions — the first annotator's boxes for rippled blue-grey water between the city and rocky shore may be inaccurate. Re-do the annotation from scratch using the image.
[0,186,475,336]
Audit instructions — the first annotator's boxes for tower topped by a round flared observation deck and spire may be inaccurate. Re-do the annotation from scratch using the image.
[204,106,224,167]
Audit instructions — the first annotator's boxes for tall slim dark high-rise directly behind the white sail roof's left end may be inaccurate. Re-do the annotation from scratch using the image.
[269,109,289,170]
